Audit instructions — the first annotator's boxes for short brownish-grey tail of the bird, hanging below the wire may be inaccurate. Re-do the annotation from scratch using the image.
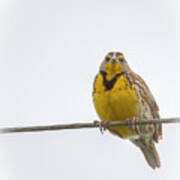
[132,138,161,169]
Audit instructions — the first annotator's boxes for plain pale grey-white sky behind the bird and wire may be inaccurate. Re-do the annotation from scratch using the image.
[0,0,180,180]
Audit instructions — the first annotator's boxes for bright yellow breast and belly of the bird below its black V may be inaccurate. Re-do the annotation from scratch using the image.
[93,74,138,138]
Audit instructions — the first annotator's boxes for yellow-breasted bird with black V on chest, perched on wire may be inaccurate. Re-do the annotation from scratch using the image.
[93,52,162,169]
